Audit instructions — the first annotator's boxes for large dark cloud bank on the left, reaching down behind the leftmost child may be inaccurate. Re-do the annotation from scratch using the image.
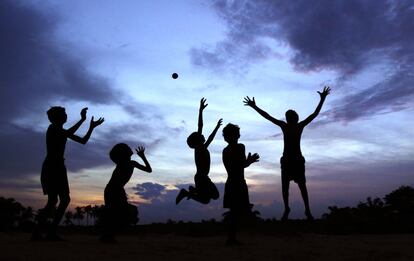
[0,0,179,179]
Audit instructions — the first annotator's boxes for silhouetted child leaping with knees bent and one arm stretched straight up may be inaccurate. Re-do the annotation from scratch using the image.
[175,98,222,204]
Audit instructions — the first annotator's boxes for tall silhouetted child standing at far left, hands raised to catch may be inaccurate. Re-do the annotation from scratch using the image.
[32,107,104,241]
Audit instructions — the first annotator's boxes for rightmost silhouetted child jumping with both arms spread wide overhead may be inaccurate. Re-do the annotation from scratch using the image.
[244,87,331,220]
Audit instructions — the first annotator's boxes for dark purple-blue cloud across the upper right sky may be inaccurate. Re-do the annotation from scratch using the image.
[191,0,414,121]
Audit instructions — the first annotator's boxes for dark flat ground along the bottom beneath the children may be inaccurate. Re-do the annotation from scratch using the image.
[0,226,414,261]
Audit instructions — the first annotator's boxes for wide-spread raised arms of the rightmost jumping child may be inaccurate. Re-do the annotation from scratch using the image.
[243,86,331,127]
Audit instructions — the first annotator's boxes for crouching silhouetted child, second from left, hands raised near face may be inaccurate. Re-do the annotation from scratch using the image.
[100,143,152,243]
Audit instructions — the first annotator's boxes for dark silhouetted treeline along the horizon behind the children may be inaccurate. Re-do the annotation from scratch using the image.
[0,186,414,232]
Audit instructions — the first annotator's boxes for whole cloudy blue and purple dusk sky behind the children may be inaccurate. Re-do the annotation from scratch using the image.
[0,0,414,223]
